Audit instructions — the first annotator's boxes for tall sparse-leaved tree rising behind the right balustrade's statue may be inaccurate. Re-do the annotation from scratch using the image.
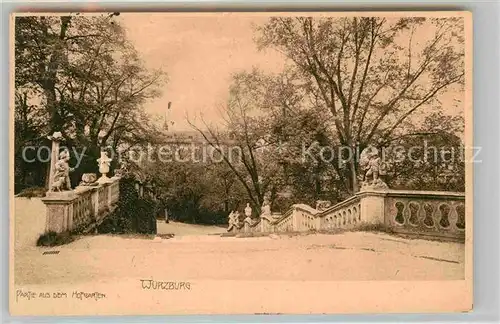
[258,17,464,192]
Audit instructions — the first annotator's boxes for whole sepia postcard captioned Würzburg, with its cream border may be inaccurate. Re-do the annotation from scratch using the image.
[9,11,472,316]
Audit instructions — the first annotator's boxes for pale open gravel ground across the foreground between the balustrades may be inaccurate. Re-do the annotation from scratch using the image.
[14,232,465,285]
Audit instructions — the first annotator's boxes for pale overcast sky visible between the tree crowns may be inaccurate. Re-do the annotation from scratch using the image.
[119,13,463,130]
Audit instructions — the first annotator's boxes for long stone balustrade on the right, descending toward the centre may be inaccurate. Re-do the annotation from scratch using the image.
[231,189,465,241]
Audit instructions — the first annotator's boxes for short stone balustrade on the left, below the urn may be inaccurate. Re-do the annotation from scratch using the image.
[42,177,120,233]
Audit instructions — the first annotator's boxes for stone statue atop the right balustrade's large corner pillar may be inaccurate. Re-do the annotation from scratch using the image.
[359,146,388,189]
